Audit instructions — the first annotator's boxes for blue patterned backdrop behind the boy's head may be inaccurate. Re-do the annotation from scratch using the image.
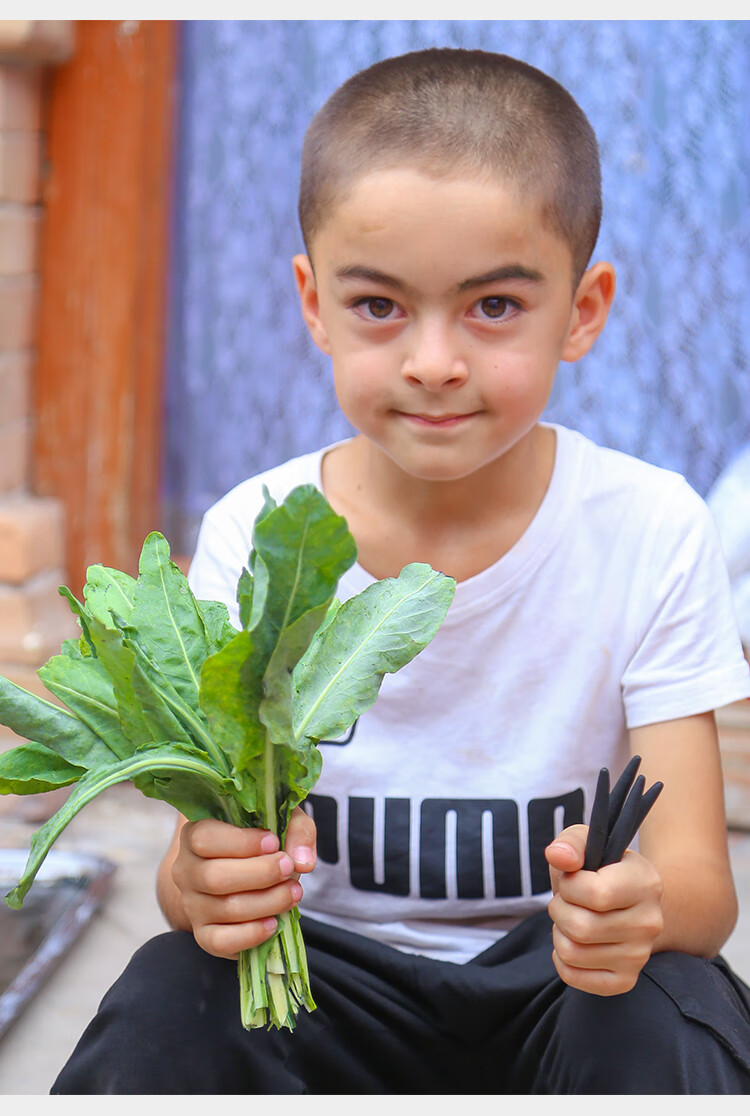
[165,20,750,551]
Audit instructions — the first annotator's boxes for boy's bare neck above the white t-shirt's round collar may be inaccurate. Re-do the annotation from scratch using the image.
[323,426,556,581]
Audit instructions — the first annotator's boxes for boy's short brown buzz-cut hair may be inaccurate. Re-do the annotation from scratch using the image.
[299,48,602,285]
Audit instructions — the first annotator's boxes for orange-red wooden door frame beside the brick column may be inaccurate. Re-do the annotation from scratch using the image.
[32,20,177,589]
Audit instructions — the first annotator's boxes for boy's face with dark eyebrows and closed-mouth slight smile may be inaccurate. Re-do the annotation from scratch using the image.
[295,169,614,481]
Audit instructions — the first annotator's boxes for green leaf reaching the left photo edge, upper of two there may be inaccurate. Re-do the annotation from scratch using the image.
[0,676,113,767]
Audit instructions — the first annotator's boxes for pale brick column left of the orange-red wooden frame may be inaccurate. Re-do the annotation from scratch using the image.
[0,20,76,748]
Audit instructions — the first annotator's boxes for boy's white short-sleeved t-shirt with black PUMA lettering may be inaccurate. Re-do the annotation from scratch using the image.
[190,426,750,962]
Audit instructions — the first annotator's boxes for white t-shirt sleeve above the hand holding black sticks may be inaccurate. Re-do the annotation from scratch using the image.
[623,481,750,728]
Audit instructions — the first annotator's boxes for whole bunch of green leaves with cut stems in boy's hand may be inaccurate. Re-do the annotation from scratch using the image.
[0,485,455,1028]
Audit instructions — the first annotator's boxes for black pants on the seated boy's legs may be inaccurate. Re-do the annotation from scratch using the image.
[51,912,750,1095]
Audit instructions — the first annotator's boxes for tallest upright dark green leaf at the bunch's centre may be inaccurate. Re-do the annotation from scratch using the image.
[200,484,356,833]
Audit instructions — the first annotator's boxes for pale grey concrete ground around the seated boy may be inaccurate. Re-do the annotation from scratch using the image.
[0,785,750,1096]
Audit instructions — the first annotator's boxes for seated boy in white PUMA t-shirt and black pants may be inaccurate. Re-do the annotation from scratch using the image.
[55,50,750,1094]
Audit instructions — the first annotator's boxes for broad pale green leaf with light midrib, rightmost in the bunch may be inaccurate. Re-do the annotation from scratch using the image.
[294,562,455,741]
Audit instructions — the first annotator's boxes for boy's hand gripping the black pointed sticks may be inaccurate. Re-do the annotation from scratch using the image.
[546,825,664,995]
